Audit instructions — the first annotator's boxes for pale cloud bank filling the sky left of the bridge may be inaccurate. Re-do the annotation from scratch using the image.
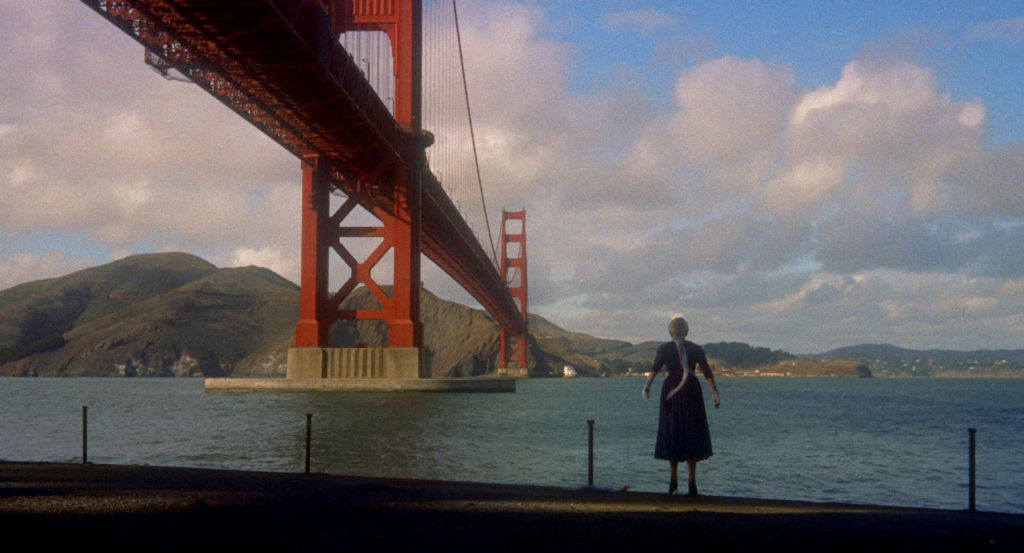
[0,2,301,255]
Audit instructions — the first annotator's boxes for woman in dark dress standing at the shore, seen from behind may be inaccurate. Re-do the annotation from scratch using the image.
[642,316,720,496]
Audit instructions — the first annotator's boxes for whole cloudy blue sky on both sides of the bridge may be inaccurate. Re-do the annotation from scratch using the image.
[0,0,1024,353]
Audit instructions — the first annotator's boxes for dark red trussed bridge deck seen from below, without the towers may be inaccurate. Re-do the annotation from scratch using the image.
[82,0,522,331]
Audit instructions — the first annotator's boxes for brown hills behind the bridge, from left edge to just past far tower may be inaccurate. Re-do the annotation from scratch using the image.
[0,253,548,376]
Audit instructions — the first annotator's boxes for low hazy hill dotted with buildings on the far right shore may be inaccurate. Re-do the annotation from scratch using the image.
[808,344,1024,377]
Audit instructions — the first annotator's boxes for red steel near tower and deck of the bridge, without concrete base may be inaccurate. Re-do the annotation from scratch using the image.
[82,0,525,354]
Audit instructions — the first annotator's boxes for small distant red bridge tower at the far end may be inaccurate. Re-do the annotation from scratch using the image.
[498,210,529,369]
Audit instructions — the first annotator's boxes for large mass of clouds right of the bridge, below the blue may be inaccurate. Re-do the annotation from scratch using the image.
[442,5,1024,350]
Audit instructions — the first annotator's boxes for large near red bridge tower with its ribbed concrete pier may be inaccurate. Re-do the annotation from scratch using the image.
[288,0,430,378]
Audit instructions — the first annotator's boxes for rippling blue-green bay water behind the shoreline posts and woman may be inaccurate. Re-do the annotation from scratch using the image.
[0,378,1024,513]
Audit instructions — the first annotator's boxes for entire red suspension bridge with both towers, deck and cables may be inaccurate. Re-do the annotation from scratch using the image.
[82,0,527,379]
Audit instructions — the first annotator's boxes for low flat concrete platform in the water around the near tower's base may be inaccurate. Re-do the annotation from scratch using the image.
[206,377,515,393]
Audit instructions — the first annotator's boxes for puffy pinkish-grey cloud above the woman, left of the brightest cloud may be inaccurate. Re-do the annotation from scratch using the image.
[627,57,797,209]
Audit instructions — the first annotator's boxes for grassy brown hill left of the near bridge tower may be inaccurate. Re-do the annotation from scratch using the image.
[0,253,299,376]
